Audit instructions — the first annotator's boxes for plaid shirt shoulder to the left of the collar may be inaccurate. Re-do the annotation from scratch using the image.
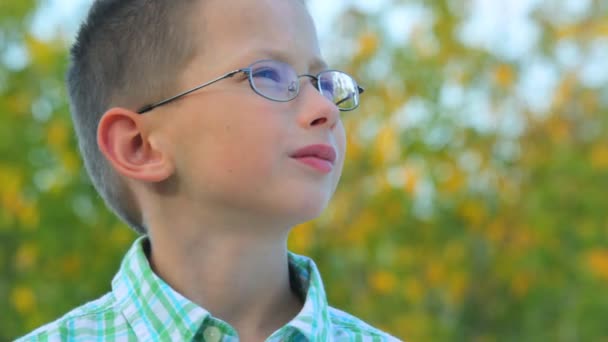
[16,292,127,342]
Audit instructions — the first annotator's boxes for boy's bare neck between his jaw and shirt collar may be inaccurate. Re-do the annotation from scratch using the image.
[143,221,302,340]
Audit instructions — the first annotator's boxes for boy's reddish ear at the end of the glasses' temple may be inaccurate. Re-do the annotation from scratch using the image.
[97,108,174,182]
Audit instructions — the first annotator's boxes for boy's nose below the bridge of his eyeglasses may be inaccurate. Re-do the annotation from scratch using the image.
[298,81,340,129]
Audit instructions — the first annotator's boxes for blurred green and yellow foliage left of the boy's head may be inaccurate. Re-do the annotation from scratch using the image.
[0,0,134,341]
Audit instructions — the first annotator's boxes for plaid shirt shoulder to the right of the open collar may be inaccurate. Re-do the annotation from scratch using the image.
[328,307,401,342]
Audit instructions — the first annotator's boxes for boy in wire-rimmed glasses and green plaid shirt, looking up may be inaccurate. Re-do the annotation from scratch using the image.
[17,0,396,341]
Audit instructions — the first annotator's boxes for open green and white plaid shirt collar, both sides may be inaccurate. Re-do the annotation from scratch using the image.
[112,236,331,341]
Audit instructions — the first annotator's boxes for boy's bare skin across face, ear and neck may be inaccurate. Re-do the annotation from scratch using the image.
[98,0,345,341]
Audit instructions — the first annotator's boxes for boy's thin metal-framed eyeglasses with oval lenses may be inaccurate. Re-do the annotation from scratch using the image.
[137,60,364,114]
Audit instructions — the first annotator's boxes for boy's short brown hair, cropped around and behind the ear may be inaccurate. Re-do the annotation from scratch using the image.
[66,0,197,233]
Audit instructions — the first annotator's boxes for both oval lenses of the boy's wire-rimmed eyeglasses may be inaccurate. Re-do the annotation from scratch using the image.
[249,60,359,110]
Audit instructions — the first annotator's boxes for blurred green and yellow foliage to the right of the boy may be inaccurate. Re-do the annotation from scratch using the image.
[291,0,608,341]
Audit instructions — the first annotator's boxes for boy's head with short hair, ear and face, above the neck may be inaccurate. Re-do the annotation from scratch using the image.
[68,0,352,233]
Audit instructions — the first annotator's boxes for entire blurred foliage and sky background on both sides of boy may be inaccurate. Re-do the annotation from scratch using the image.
[0,0,608,341]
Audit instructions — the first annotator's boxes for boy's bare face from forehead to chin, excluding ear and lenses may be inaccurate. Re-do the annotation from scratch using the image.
[152,0,345,224]
